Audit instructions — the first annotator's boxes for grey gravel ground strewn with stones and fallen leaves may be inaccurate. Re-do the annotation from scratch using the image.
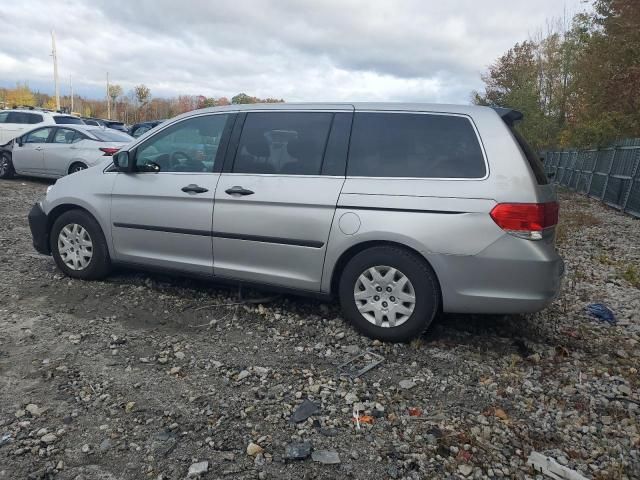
[0,179,640,480]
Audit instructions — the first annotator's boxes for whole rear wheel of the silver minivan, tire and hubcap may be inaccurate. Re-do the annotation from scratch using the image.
[338,245,440,342]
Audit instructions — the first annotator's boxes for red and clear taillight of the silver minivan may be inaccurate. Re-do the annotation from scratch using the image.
[490,202,558,240]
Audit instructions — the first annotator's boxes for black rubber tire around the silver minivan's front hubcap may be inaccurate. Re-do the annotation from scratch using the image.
[49,210,111,280]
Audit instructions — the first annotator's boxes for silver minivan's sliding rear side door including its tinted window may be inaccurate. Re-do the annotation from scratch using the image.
[213,111,352,291]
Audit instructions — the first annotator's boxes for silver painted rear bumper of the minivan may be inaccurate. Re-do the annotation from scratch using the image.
[428,236,564,314]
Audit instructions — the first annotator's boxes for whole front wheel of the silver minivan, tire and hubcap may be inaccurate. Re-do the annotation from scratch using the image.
[50,210,111,280]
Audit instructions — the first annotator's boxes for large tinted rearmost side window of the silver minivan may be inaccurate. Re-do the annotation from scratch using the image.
[347,113,487,178]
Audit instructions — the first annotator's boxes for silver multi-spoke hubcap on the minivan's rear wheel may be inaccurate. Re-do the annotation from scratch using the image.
[353,265,416,328]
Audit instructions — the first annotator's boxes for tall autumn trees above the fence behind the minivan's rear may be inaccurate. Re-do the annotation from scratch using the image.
[472,0,640,150]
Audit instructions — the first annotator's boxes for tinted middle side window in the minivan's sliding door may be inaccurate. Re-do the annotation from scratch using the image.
[233,112,333,175]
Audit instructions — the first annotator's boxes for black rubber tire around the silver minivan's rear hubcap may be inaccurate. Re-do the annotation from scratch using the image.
[338,246,440,342]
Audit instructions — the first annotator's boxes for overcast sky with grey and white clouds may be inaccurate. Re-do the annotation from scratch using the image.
[0,0,585,103]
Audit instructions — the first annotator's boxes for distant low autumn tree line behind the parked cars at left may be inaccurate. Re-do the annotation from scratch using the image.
[0,82,284,124]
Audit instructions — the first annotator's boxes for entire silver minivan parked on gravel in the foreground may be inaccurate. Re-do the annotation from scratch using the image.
[29,104,564,341]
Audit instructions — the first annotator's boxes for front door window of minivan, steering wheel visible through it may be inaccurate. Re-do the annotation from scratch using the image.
[136,114,229,172]
